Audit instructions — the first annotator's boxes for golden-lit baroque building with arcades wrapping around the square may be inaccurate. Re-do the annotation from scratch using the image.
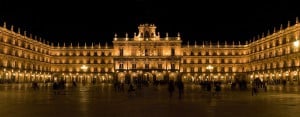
[0,18,300,84]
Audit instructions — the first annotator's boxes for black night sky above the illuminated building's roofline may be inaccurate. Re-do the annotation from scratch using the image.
[0,0,300,43]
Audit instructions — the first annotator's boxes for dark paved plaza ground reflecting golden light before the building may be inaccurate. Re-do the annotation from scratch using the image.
[0,84,300,117]
